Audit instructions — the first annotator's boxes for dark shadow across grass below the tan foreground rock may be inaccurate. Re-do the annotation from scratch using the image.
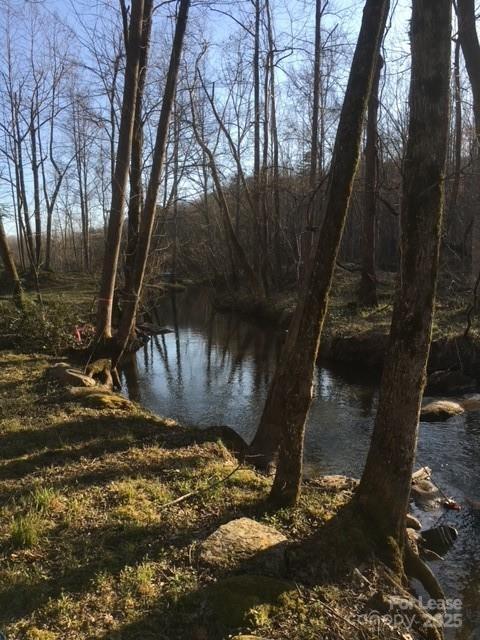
[92,503,371,640]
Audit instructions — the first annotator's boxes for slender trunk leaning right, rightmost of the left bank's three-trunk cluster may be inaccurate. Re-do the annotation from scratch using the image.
[117,0,190,361]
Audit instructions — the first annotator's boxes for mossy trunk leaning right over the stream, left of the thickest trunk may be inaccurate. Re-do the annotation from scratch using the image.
[254,0,389,505]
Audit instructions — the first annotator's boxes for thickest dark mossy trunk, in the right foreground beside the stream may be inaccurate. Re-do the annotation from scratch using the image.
[357,0,451,549]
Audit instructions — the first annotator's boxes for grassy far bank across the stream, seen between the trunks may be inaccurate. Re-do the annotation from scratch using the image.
[215,268,480,378]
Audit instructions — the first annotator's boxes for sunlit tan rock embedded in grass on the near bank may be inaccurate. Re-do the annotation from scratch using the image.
[199,518,287,575]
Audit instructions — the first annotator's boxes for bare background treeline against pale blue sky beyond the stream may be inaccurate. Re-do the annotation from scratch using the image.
[0,0,480,298]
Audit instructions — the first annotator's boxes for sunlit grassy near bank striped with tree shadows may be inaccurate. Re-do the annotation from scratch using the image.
[0,351,440,640]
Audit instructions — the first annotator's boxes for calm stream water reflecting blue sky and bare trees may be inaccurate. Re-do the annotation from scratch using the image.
[124,289,480,640]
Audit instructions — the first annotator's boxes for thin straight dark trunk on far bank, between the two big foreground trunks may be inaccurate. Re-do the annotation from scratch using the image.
[359,55,383,307]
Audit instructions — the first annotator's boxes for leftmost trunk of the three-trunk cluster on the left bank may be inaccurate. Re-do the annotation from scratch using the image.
[97,0,144,339]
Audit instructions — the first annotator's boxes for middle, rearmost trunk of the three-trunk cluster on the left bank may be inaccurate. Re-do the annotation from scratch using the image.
[125,0,153,290]
